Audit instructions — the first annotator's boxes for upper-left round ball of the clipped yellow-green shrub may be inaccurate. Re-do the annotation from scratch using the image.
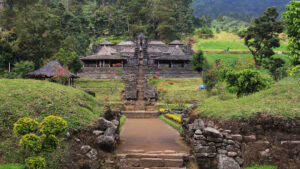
[14,117,39,135]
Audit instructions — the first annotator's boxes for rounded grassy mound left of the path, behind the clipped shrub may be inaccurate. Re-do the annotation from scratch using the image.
[0,79,103,168]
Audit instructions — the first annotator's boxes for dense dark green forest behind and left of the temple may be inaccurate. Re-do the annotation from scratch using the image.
[0,0,195,72]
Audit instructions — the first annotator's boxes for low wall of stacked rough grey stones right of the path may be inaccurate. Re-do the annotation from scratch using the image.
[182,106,243,169]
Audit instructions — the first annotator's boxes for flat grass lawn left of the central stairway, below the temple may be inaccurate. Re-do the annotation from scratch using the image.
[75,79,124,107]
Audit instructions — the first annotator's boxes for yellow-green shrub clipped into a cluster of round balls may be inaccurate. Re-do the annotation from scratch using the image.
[14,116,67,169]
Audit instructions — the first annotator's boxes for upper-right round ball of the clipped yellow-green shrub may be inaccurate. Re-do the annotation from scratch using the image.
[40,116,67,136]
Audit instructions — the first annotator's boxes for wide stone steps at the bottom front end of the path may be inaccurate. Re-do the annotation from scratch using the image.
[117,150,189,169]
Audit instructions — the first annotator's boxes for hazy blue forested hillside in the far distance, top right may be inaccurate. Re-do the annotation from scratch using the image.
[191,0,291,21]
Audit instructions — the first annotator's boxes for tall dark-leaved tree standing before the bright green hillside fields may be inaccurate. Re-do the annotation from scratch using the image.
[240,7,284,69]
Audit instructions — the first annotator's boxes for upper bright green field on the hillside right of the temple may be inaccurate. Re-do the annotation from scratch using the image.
[194,32,287,52]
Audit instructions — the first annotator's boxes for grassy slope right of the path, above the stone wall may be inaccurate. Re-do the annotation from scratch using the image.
[197,78,300,119]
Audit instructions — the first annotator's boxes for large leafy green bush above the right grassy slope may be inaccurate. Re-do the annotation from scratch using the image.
[221,69,272,96]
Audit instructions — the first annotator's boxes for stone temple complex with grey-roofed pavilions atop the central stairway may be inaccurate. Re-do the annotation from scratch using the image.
[78,34,200,79]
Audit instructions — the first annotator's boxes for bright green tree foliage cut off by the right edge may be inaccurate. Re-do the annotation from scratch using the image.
[283,1,300,65]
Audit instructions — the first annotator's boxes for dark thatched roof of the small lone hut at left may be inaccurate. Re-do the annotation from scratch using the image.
[26,60,78,78]
